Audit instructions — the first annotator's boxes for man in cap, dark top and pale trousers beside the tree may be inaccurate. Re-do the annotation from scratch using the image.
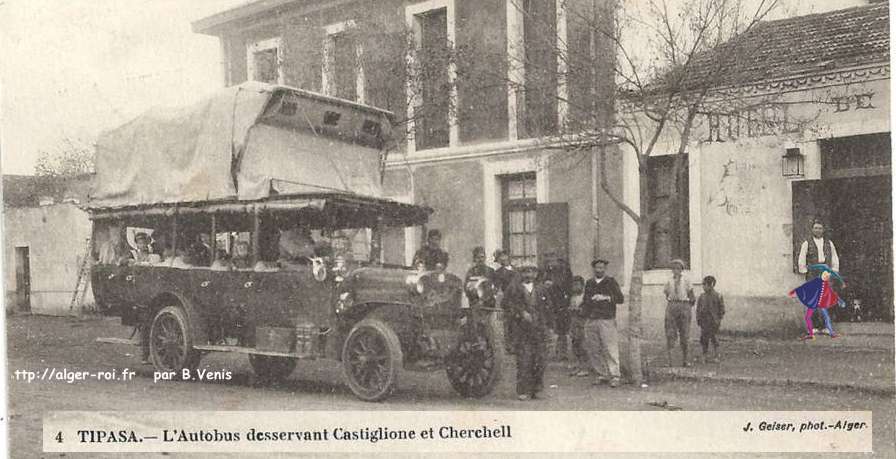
[582,259,623,387]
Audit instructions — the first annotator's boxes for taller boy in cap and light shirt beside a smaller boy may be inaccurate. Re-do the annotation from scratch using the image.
[663,259,696,367]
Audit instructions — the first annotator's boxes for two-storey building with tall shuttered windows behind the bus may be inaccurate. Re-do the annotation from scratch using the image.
[193,0,622,280]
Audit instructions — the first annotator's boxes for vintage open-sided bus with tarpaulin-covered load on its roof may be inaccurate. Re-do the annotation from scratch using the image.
[89,83,503,401]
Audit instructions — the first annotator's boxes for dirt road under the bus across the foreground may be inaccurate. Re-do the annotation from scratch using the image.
[7,316,896,458]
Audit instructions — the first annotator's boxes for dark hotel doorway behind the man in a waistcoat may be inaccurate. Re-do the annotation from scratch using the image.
[792,133,894,321]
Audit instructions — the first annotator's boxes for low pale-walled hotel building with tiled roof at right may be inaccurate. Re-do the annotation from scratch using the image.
[623,2,893,334]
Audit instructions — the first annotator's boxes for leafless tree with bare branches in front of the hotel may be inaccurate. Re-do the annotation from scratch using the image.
[490,0,778,383]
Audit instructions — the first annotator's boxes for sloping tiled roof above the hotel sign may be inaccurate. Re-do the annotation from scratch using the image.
[664,1,890,91]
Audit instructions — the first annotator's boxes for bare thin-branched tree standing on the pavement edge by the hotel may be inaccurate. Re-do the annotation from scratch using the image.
[561,0,777,383]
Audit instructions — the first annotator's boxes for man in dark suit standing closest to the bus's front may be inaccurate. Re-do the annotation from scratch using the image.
[504,266,553,400]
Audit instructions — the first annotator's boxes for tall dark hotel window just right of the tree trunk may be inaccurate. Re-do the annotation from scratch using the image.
[647,155,691,269]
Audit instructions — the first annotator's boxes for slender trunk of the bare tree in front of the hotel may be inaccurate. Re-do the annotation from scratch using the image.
[628,172,650,385]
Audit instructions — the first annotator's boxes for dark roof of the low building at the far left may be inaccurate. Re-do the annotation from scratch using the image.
[3,174,93,207]
